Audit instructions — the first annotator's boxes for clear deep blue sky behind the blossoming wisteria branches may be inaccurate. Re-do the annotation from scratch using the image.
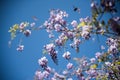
[0,0,105,80]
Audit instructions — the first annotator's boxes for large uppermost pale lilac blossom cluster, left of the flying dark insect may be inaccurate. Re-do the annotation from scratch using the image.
[43,9,68,38]
